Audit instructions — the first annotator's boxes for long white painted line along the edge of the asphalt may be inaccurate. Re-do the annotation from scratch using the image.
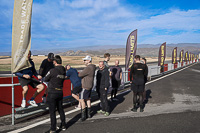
[8,64,195,133]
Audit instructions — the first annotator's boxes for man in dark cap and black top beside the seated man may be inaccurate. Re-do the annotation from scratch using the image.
[38,53,54,103]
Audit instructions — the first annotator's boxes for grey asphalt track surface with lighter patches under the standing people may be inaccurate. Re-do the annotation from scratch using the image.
[0,64,200,133]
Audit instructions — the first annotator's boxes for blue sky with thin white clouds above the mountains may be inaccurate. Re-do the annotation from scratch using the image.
[0,0,200,52]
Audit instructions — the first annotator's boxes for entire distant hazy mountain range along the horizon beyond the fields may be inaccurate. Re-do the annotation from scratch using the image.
[0,43,200,57]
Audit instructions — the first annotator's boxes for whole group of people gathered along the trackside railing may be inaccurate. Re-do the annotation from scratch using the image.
[15,51,148,132]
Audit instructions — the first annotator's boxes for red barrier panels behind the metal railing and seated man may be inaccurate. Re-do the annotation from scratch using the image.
[0,77,71,116]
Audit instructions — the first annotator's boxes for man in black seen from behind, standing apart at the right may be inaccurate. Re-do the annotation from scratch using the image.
[130,55,148,112]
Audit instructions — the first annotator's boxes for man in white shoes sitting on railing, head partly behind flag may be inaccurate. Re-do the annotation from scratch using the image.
[15,51,44,108]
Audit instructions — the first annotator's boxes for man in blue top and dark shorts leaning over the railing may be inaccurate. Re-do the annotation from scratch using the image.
[65,64,82,109]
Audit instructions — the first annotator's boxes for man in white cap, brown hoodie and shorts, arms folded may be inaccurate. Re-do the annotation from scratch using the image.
[78,55,96,121]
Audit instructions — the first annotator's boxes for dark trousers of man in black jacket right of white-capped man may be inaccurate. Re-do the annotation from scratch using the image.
[99,88,109,112]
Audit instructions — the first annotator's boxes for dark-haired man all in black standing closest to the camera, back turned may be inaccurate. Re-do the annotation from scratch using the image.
[44,55,66,133]
